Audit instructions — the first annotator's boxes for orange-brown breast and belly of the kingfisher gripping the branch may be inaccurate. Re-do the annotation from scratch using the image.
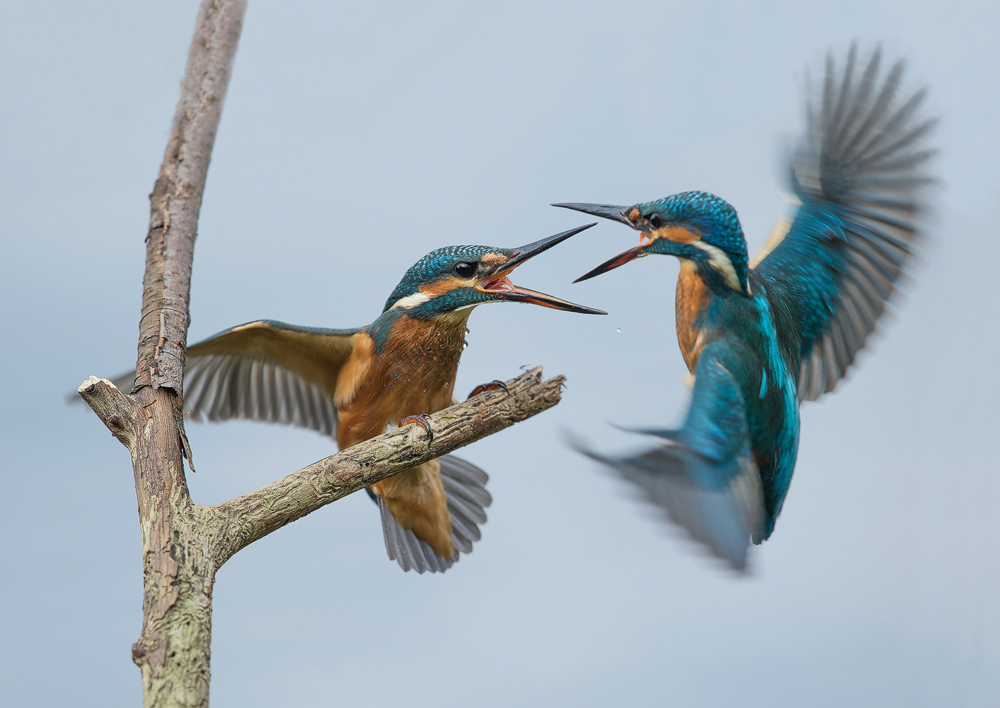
[336,310,471,558]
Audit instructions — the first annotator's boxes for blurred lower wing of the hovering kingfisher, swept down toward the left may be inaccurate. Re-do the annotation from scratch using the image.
[585,349,766,570]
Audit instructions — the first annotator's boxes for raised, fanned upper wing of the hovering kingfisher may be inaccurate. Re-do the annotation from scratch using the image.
[756,46,935,400]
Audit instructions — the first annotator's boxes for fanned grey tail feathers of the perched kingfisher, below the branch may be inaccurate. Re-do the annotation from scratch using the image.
[369,455,493,573]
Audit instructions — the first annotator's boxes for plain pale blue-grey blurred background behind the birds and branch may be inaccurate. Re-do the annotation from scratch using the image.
[0,0,1000,708]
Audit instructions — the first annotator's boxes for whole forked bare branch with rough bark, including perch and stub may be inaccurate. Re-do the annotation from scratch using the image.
[79,0,562,708]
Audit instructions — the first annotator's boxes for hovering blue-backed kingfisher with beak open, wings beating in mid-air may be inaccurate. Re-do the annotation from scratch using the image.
[554,47,934,570]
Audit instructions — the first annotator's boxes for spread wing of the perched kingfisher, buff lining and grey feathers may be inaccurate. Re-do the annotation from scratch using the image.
[107,320,361,437]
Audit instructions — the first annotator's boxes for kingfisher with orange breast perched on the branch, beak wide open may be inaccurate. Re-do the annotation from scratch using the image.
[122,224,607,573]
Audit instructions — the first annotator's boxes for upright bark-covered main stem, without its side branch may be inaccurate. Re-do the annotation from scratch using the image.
[98,0,246,706]
